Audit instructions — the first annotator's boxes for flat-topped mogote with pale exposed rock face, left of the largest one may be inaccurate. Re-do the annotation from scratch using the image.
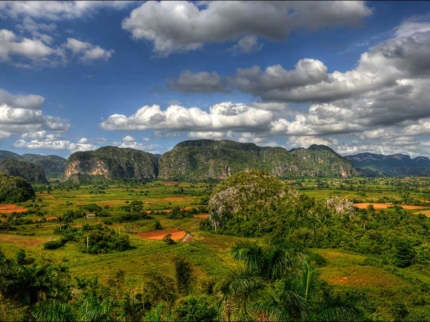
[64,146,158,182]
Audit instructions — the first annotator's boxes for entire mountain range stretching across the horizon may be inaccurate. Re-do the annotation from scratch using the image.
[0,140,430,183]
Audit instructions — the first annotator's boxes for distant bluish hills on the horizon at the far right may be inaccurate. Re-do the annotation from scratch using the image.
[345,153,430,176]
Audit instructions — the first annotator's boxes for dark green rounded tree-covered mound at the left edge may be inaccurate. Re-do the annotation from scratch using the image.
[0,173,35,203]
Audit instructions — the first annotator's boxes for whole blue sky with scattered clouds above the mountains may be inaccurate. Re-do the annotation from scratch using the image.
[0,1,430,157]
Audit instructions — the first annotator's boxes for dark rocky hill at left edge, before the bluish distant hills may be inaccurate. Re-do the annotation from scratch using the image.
[0,159,48,183]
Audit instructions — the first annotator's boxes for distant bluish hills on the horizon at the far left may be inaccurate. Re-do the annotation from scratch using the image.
[0,151,67,178]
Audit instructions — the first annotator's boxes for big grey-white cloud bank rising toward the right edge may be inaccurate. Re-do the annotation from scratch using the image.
[229,21,430,103]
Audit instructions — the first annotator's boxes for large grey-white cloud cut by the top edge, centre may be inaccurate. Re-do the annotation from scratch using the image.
[122,1,372,56]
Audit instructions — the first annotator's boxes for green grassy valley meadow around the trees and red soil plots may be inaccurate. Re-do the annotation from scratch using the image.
[0,178,430,320]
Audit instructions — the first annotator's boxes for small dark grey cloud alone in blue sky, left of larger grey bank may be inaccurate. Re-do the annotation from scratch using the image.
[166,70,229,93]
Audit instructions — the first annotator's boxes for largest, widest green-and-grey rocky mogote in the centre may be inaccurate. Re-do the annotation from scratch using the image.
[159,140,354,180]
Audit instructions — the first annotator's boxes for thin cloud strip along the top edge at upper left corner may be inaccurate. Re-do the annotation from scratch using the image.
[0,1,132,21]
